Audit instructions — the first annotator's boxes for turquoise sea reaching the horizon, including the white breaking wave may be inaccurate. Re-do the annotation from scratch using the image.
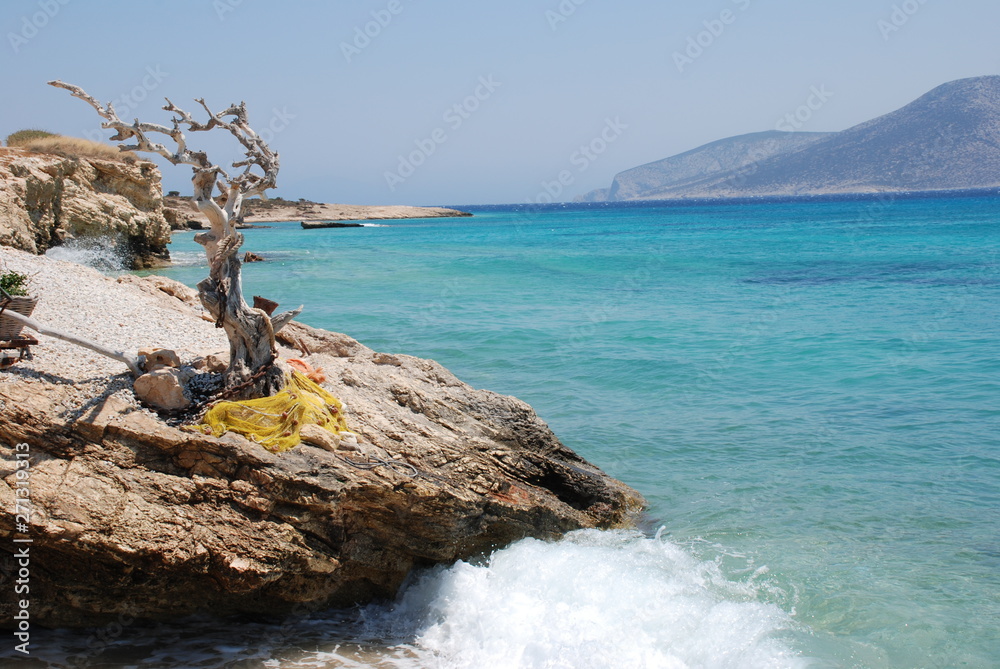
[27,196,1000,668]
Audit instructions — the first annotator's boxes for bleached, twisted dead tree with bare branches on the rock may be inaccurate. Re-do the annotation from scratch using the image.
[49,81,302,399]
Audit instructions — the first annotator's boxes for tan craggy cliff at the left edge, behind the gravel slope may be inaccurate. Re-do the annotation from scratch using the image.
[0,148,170,269]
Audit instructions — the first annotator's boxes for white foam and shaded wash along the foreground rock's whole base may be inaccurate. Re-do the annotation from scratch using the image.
[0,530,808,669]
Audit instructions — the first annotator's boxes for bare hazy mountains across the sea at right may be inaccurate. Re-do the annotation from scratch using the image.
[585,76,1000,201]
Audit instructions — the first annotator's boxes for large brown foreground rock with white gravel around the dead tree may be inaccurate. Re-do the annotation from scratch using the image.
[0,248,643,627]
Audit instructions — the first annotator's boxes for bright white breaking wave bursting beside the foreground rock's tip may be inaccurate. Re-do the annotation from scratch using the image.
[340,530,807,669]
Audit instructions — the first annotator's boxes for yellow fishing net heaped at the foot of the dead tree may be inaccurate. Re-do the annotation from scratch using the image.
[192,371,348,453]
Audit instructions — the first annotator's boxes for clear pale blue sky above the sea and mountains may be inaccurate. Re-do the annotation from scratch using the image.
[0,0,1000,205]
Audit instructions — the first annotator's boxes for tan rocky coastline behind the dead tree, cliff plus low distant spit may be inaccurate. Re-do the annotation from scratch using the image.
[0,143,471,269]
